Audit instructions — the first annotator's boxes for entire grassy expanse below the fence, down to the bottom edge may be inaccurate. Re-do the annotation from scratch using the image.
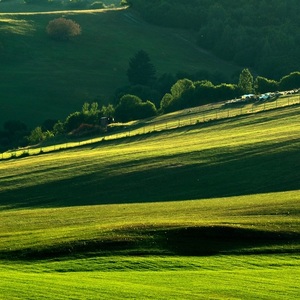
[0,105,300,299]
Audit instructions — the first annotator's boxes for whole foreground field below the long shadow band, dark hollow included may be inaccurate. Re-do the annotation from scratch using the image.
[0,191,300,299]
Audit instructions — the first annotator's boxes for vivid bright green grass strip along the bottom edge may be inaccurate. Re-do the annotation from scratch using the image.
[0,255,300,300]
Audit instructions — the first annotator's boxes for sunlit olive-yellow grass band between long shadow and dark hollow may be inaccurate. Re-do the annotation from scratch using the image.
[0,191,300,254]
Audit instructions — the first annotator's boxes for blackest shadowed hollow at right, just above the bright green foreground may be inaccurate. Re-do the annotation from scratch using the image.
[152,226,300,256]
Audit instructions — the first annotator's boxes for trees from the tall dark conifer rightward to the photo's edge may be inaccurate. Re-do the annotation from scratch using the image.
[116,50,300,114]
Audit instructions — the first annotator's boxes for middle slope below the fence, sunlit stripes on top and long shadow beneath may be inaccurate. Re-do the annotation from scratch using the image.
[0,106,300,207]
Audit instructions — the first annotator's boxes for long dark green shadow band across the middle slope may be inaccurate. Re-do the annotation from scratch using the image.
[0,139,300,209]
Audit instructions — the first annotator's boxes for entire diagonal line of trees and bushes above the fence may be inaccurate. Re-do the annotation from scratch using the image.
[0,50,300,151]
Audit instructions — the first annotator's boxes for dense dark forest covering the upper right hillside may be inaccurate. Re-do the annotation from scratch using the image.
[127,0,300,79]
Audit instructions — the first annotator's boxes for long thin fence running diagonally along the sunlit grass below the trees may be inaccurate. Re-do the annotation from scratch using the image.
[0,95,300,160]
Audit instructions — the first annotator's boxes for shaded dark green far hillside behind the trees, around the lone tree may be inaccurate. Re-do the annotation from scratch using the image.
[0,9,238,126]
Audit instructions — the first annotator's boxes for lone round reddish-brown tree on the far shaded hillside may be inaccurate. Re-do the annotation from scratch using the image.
[46,18,81,41]
